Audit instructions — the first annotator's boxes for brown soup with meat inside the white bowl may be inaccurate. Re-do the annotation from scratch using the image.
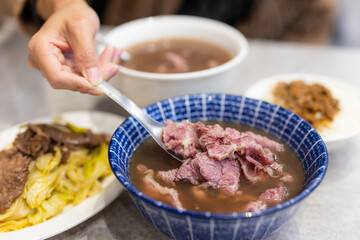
[121,39,232,73]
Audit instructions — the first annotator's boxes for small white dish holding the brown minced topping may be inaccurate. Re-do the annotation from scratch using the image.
[245,73,360,151]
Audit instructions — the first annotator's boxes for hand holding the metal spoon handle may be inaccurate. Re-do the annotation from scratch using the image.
[28,0,121,95]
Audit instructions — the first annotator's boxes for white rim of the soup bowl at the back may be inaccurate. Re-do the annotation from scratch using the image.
[104,15,249,81]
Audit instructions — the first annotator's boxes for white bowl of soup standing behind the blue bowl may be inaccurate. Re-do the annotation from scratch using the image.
[99,15,248,107]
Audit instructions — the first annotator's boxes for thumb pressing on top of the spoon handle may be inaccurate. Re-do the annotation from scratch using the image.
[68,21,102,85]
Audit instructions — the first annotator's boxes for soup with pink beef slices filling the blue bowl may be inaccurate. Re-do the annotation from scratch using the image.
[130,120,304,213]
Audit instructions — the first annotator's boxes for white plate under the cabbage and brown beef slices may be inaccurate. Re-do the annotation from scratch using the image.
[0,111,124,240]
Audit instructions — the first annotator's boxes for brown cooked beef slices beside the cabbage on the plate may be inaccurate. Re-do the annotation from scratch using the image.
[0,124,108,213]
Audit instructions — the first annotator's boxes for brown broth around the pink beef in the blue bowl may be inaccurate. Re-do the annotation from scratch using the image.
[130,122,304,213]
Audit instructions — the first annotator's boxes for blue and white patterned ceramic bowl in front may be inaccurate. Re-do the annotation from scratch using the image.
[109,94,328,239]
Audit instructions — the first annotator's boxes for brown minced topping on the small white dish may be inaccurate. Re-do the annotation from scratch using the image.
[273,80,340,129]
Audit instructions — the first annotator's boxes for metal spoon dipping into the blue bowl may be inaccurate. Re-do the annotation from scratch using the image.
[97,81,183,162]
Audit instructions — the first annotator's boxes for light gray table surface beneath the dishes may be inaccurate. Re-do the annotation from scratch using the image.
[0,21,360,240]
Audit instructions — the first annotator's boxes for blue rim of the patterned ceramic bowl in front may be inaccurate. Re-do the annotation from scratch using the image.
[108,93,329,220]
